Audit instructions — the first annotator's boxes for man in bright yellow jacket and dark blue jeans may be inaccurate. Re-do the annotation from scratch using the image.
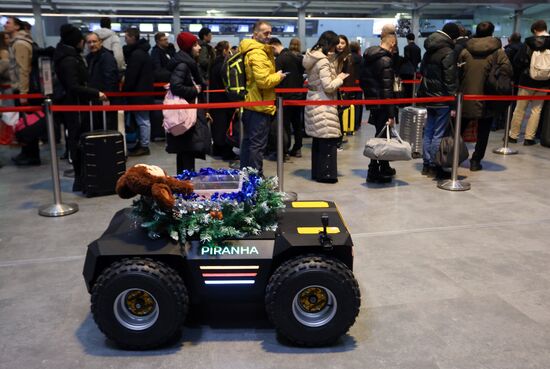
[239,21,285,174]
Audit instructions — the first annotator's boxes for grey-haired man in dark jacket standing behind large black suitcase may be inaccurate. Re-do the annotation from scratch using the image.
[86,32,120,130]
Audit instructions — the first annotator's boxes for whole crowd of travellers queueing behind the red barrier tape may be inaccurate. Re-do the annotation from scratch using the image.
[0,17,550,187]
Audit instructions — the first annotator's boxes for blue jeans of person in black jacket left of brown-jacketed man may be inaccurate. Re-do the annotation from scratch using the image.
[422,106,451,166]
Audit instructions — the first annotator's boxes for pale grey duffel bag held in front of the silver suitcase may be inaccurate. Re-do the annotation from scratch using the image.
[363,125,412,161]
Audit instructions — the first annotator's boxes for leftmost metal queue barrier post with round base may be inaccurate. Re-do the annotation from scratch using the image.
[38,98,78,217]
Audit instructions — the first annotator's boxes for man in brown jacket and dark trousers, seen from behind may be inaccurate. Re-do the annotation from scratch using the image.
[458,21,513,171]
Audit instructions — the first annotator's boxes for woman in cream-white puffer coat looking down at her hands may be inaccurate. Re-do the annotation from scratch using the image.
[303,31,348,183]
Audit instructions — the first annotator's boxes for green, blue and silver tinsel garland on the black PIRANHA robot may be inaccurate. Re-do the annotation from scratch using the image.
[133,168,284,246]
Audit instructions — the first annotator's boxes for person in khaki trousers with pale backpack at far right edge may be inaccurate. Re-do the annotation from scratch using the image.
[508,20,550,146]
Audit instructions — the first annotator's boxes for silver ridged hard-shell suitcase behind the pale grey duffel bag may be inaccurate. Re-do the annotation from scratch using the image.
[399,106,428,159]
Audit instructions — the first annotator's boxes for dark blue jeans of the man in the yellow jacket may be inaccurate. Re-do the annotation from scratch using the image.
[240,109,273,174]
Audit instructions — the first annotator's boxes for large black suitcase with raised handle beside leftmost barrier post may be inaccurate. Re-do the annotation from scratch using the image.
[80,105,126,197]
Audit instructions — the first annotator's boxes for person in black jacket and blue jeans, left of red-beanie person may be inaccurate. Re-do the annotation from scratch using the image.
[122,28,154,156]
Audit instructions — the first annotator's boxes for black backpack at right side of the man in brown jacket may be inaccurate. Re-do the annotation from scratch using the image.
[483,50,514,112]
